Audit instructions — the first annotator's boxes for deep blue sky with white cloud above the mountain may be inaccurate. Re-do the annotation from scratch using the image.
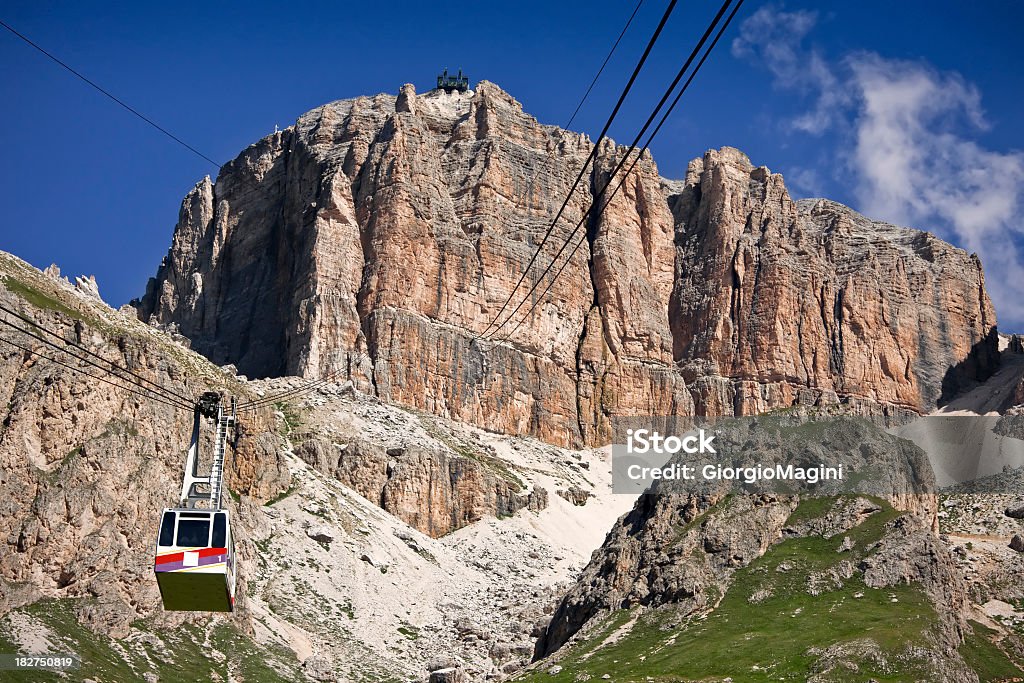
[0,0,1024,331]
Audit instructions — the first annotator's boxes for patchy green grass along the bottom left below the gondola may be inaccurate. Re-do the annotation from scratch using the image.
[0,599,302,683]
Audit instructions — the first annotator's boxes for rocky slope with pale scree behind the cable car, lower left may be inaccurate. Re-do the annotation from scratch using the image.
[0,252,631,681]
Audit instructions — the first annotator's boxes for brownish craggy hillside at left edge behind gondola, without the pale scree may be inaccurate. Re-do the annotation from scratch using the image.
[0,253,289,637]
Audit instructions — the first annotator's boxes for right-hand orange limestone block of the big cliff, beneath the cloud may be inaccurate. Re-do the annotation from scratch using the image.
[670,148,998,414]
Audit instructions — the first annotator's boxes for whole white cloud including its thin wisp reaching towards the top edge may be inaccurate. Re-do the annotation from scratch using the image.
[733,7,1024,330]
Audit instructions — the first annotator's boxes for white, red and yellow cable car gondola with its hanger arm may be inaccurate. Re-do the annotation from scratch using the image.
[154,392,236,612]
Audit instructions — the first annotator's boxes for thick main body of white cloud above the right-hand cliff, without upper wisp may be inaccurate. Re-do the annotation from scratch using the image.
[849,54,1024,329]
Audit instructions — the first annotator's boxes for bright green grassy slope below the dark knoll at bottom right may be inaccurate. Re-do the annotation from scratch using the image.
[518,499,1016,683]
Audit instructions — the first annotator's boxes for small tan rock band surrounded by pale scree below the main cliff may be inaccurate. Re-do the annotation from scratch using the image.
[295,438,548,538]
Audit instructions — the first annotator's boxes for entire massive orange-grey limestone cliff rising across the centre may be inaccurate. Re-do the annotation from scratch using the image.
[136,82,997,444]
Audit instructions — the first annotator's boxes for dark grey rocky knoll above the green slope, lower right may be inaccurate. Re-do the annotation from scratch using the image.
[536,418,950,658]
